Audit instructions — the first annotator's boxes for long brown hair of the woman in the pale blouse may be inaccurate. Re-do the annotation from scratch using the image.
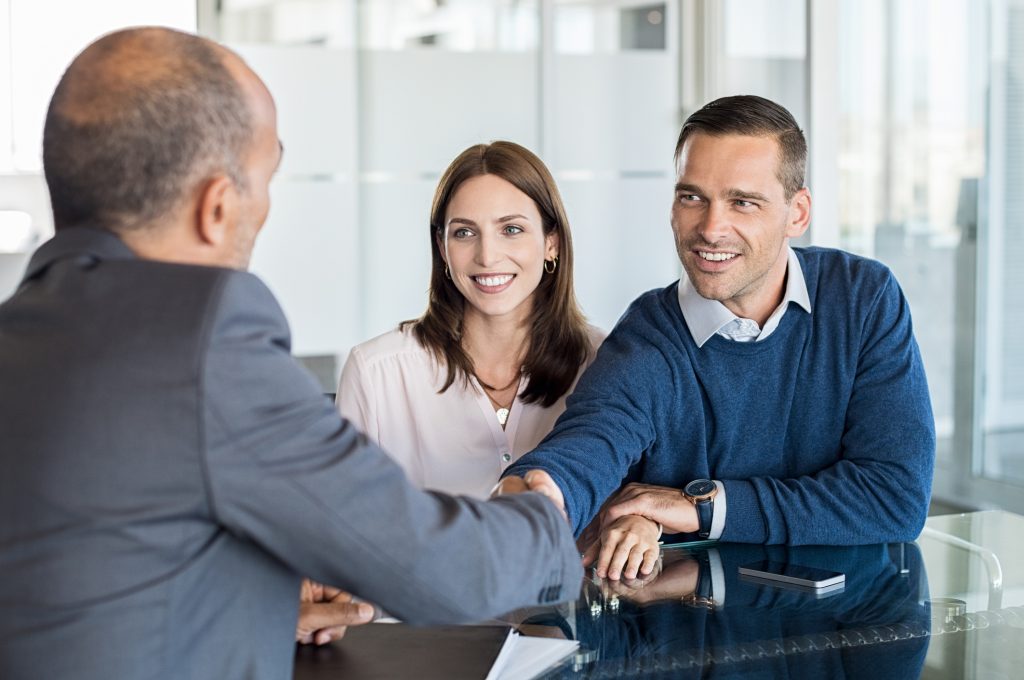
[400,141,590,407]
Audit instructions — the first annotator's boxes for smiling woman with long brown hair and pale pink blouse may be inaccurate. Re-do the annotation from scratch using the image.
[338,141,603,498]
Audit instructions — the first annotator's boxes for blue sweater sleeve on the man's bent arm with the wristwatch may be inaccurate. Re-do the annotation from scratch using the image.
[722,273,935,545]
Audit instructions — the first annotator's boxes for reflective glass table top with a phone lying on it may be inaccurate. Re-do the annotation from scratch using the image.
[515,511,1024,680]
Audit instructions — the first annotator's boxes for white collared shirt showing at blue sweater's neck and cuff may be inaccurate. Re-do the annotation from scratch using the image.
[679,248,811,540]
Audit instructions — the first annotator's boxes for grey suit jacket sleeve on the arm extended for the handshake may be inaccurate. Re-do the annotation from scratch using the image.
[195,273,583,624]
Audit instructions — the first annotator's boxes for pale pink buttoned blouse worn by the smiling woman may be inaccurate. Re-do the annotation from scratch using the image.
[338,327,604,498]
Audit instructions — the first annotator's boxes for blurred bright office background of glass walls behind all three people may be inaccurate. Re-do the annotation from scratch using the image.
[0,0,1024,512]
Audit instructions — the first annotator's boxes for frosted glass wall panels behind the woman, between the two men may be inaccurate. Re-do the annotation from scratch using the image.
[201,0,680,354]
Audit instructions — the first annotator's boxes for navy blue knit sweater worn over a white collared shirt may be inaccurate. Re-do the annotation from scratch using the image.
[505,248,935,545]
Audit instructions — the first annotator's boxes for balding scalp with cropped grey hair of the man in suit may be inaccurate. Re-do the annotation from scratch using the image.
[43,28,253,232]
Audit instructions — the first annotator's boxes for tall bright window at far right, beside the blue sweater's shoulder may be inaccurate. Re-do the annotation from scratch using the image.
[835,0,1024,509]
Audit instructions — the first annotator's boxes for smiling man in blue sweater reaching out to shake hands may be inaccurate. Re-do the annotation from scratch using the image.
[502,96,935,579]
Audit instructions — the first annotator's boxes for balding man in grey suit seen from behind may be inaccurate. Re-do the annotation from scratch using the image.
[0,29,582,680]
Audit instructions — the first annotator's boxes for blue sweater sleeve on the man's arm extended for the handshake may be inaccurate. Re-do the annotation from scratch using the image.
[503,298,676,536]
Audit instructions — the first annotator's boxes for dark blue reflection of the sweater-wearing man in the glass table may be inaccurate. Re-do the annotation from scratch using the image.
[546,544,930,680]
